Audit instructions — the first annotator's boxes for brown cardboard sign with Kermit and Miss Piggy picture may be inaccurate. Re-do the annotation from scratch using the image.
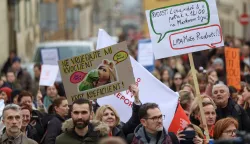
[58,42,135,103]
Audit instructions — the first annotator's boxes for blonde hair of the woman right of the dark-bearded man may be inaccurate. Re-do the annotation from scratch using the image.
[95,105,120,126]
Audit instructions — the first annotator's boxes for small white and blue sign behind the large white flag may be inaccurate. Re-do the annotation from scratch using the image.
[137,39,154,72]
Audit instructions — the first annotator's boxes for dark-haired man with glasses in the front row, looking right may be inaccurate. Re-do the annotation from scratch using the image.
[127,103,179,144]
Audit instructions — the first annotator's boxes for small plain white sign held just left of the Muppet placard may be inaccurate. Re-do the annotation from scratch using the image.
[39,65,59,86]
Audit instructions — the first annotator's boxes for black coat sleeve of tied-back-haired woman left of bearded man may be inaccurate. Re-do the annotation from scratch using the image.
[44,118,62,144]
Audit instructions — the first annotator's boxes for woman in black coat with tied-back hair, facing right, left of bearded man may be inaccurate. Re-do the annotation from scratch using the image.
[44,97,69,144]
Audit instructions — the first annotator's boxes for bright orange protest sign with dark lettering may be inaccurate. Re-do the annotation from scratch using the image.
[225,47,241,90]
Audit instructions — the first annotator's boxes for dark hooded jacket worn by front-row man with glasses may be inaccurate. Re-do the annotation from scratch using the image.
[131,124,179,144]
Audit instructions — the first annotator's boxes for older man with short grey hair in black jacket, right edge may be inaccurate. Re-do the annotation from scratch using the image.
[212,84,250,132]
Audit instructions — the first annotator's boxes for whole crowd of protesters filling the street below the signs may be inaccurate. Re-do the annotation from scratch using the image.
[0,33,250,144]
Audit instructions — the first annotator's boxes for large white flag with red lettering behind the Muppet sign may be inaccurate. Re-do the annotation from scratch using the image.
[97,30,178,129]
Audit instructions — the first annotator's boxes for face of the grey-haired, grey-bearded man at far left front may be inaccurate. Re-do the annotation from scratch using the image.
[3,109,22,134]
